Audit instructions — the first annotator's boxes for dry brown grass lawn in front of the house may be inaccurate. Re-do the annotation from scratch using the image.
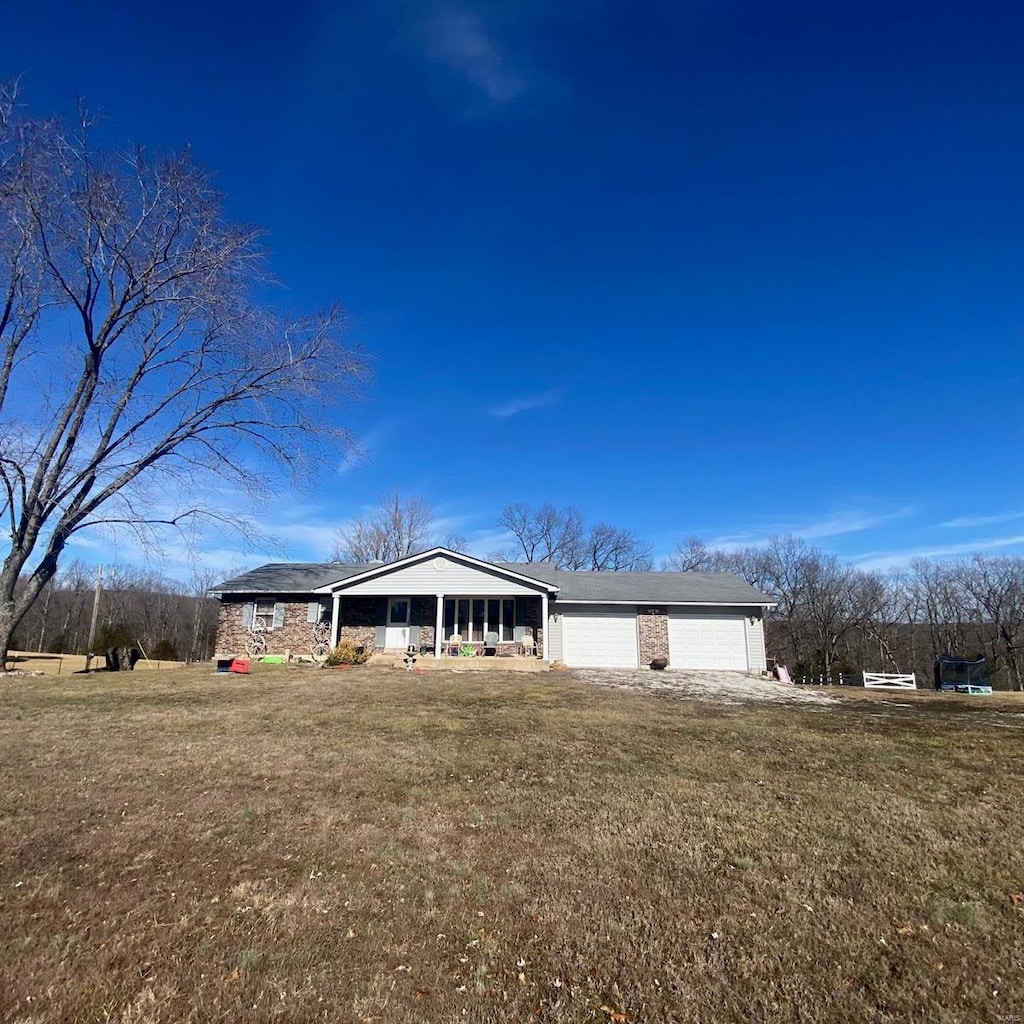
[0,667,1024,1024]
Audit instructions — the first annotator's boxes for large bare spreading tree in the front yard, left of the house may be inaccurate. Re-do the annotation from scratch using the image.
[0,90,365,654]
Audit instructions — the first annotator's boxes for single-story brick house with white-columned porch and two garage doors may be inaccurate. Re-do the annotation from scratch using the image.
[210,548,773,673]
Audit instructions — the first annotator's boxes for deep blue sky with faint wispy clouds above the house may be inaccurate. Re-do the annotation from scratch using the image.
[0,0,1024,570]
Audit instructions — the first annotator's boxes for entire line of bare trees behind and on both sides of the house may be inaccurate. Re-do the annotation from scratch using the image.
[22,492,1007,689]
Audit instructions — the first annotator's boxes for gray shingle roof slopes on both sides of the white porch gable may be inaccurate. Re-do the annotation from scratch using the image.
[210,562,774,605]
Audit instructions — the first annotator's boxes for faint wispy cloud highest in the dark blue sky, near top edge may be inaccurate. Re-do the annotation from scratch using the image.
[423,4,527,103]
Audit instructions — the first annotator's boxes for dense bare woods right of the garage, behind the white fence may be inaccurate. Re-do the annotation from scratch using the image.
[664,537,1024,690]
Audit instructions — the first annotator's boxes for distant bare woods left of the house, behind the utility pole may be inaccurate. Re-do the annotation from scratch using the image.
[11,561,218,662]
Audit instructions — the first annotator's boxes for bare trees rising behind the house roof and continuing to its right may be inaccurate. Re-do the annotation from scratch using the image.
[333,492,1024,689]
